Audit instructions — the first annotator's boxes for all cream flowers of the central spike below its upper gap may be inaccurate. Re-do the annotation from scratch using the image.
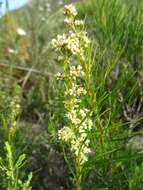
[58,65,93,165]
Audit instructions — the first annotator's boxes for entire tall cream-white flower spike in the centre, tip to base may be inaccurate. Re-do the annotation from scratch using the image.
[52,5,93,165]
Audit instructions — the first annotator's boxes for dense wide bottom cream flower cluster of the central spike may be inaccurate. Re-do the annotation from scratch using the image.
[58,106,93,165]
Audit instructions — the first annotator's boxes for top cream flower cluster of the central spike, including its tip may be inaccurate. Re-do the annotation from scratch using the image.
[52,5,90,60]
